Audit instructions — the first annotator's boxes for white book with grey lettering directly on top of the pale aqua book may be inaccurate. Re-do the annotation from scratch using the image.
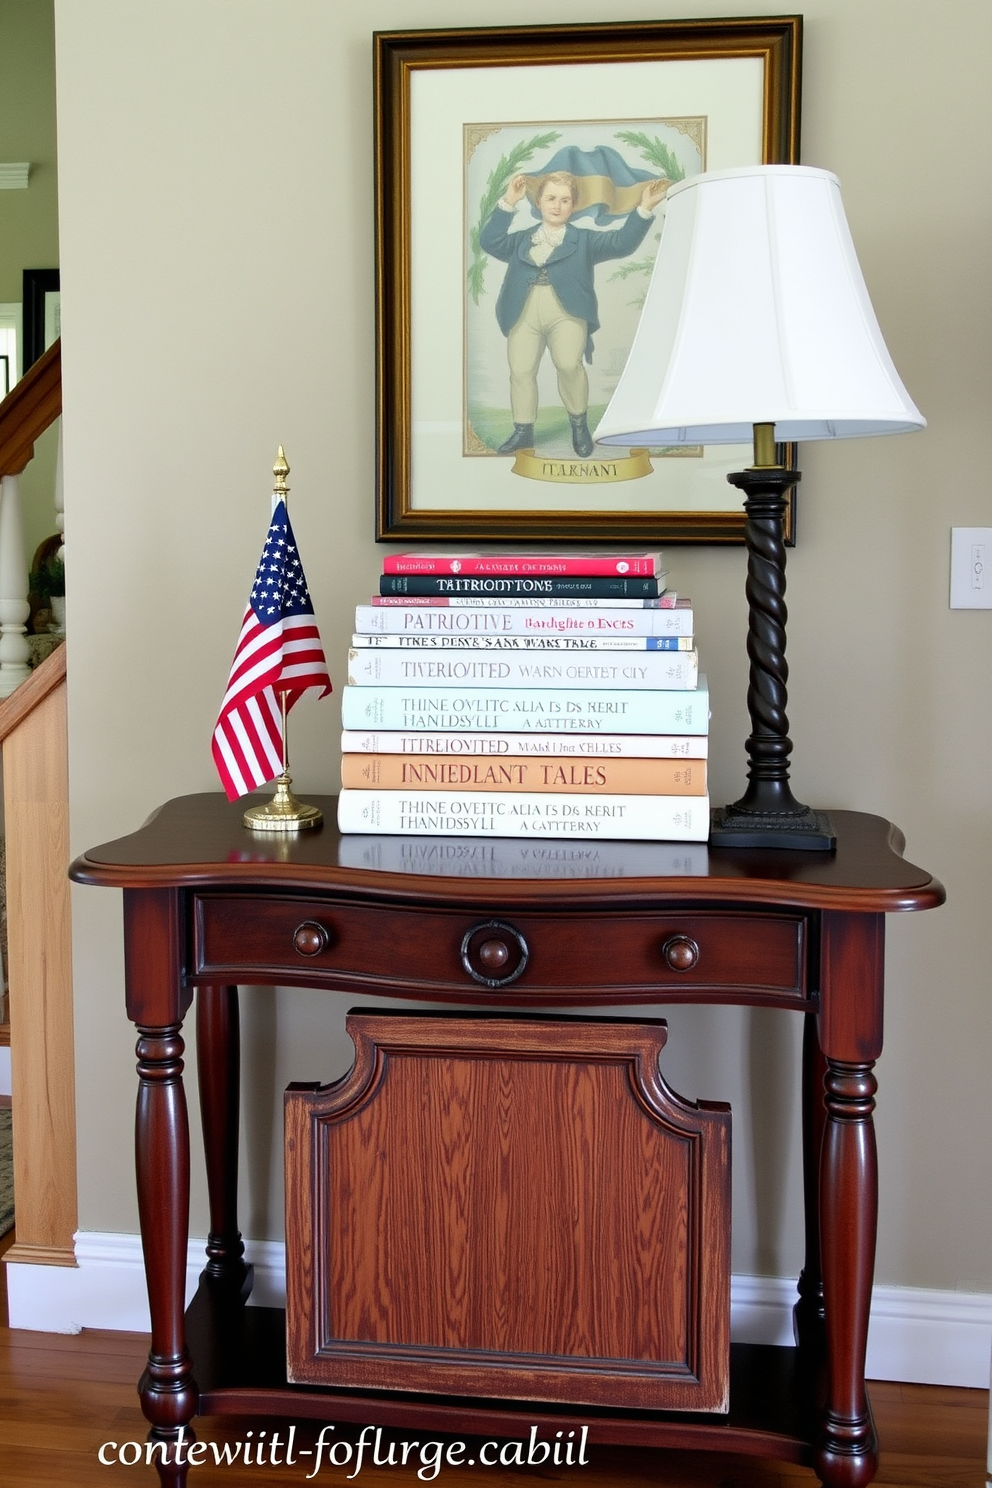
[348,647,699,692]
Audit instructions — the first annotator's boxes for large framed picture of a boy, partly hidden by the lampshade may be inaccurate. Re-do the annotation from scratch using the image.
[375,16,802,543]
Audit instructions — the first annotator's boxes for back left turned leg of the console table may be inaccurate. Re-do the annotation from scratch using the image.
[196,987,251,1296]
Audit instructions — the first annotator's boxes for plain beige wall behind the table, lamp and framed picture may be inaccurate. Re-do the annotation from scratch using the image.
[57,0,992,1292]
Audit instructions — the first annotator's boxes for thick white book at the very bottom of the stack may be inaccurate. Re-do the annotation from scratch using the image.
[338,790,709,842]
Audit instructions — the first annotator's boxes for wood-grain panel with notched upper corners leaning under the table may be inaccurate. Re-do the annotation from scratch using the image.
[286,1015,730,1411]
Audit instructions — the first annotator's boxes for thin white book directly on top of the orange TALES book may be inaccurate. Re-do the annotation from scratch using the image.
[341,729,709,759]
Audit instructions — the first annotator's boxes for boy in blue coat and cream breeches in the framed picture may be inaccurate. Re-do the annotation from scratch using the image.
[479,171,668,460]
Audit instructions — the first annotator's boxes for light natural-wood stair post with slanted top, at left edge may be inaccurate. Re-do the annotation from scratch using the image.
[3,682,76,1265]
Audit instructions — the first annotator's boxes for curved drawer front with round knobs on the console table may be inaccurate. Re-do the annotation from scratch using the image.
[190,893,809,1003]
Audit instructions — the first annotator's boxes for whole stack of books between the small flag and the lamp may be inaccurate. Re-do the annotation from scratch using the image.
[338,554,709,842]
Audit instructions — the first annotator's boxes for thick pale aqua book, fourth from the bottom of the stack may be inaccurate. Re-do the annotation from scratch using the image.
[341,677,709,734]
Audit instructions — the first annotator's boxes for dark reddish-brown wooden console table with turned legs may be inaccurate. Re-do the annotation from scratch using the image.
[71,795,943,1488]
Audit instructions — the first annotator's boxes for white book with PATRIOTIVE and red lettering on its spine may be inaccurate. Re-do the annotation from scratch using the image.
[355,600,693,635]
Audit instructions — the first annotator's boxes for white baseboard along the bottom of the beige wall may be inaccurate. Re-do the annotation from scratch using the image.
[7,1231,992,1390]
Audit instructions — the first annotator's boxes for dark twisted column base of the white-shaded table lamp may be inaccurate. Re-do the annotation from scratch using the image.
[709,466,836,853]
